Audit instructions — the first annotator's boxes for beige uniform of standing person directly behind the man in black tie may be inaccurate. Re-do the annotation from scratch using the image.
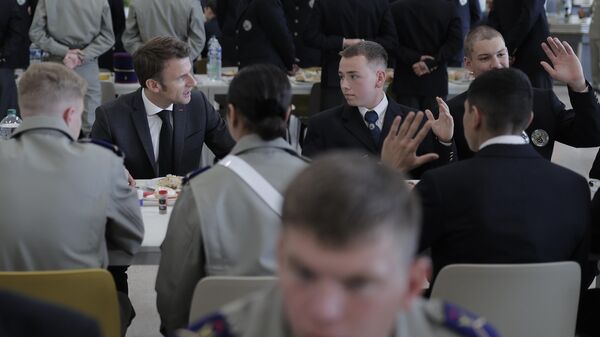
[121,0,206,60]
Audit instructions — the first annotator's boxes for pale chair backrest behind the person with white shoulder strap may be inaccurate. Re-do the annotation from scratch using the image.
[190,276,277,322]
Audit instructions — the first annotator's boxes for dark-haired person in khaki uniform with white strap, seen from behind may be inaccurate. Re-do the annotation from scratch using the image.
[156,65,306,333]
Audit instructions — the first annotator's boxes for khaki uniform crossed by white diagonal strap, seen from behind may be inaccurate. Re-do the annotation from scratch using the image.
[156,135,307,331]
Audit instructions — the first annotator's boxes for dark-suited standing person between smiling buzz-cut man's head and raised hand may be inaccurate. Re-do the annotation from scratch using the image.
[488,0,552,89]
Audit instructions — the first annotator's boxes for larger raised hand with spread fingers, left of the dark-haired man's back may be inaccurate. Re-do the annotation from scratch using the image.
[381,111,439,171]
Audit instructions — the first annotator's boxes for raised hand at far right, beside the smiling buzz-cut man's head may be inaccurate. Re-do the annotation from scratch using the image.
[540,37,586,91]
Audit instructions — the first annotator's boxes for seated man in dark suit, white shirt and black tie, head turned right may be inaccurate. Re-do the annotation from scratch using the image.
[91,37,234,179]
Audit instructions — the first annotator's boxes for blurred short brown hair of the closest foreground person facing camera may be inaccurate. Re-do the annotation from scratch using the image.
[282,152,421,261]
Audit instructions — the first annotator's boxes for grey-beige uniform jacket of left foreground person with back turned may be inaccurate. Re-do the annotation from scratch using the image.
[0,116,144,270]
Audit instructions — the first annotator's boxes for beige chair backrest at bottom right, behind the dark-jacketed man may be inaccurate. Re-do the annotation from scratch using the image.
[431,261,581,337]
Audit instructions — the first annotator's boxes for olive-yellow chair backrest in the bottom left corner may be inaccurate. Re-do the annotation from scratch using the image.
[0,269,121,337]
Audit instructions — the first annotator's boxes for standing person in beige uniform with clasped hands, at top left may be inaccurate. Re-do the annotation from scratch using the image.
[29,0,115,134]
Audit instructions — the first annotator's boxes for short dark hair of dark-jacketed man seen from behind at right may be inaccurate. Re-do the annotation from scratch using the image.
[467,68,533,134]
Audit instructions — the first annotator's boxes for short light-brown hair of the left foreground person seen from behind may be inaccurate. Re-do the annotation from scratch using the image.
[18,62,87,116]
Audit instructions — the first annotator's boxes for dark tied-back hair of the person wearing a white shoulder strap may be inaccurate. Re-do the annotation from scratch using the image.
[228,64,292,140]
